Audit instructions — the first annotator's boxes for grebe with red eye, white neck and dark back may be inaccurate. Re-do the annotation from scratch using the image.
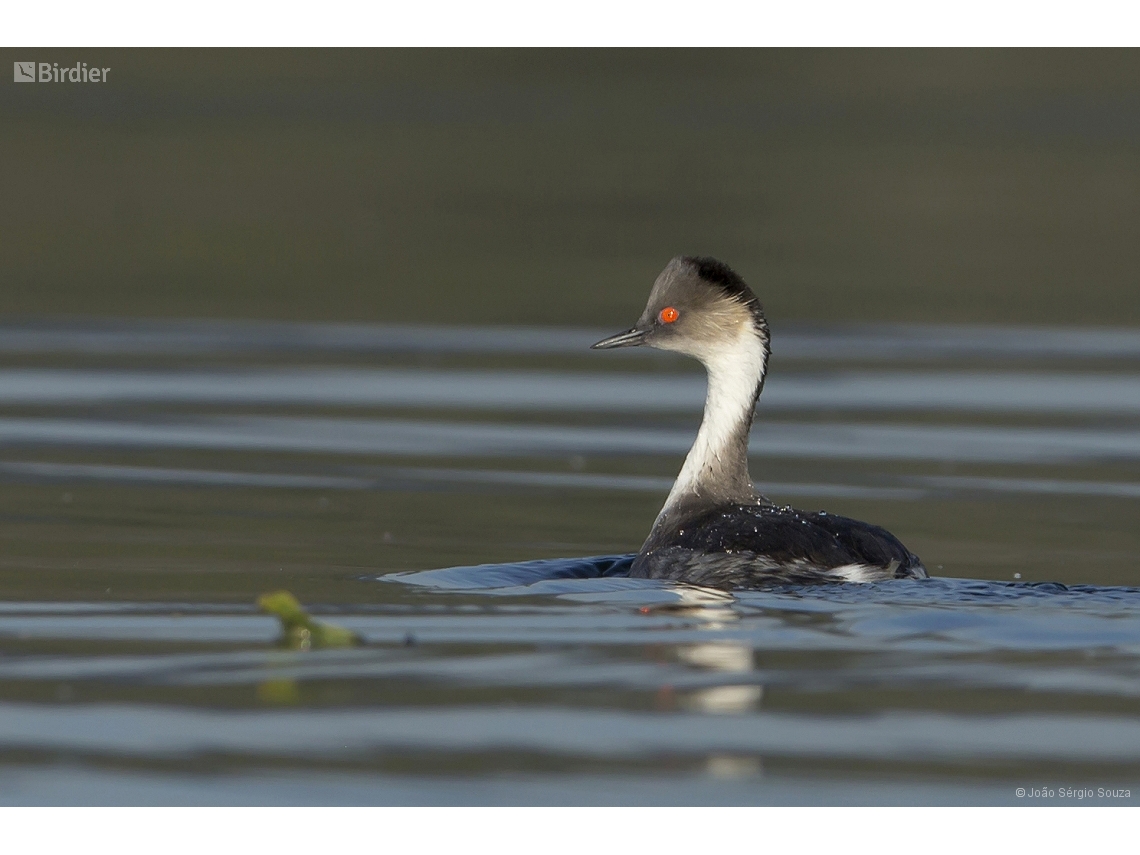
[593,255,927,588]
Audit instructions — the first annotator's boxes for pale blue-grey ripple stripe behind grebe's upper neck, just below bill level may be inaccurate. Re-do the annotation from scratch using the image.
[0,368,1140,415]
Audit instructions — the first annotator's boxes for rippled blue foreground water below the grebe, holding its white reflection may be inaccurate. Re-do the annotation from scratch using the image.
[0,572,1140,804]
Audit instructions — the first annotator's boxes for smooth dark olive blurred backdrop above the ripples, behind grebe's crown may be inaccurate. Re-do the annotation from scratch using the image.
[0,49,1140,326]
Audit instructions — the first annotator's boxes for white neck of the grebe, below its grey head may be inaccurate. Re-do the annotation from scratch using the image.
[659,324,768,519]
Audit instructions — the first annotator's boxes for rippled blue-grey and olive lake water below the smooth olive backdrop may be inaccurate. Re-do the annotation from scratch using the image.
[0,320,1140,805]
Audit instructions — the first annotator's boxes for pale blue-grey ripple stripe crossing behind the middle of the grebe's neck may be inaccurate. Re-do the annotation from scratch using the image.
[0,416,1140,463]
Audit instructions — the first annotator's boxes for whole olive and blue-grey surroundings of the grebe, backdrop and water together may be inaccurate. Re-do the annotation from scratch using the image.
[0,49,1140,804]
